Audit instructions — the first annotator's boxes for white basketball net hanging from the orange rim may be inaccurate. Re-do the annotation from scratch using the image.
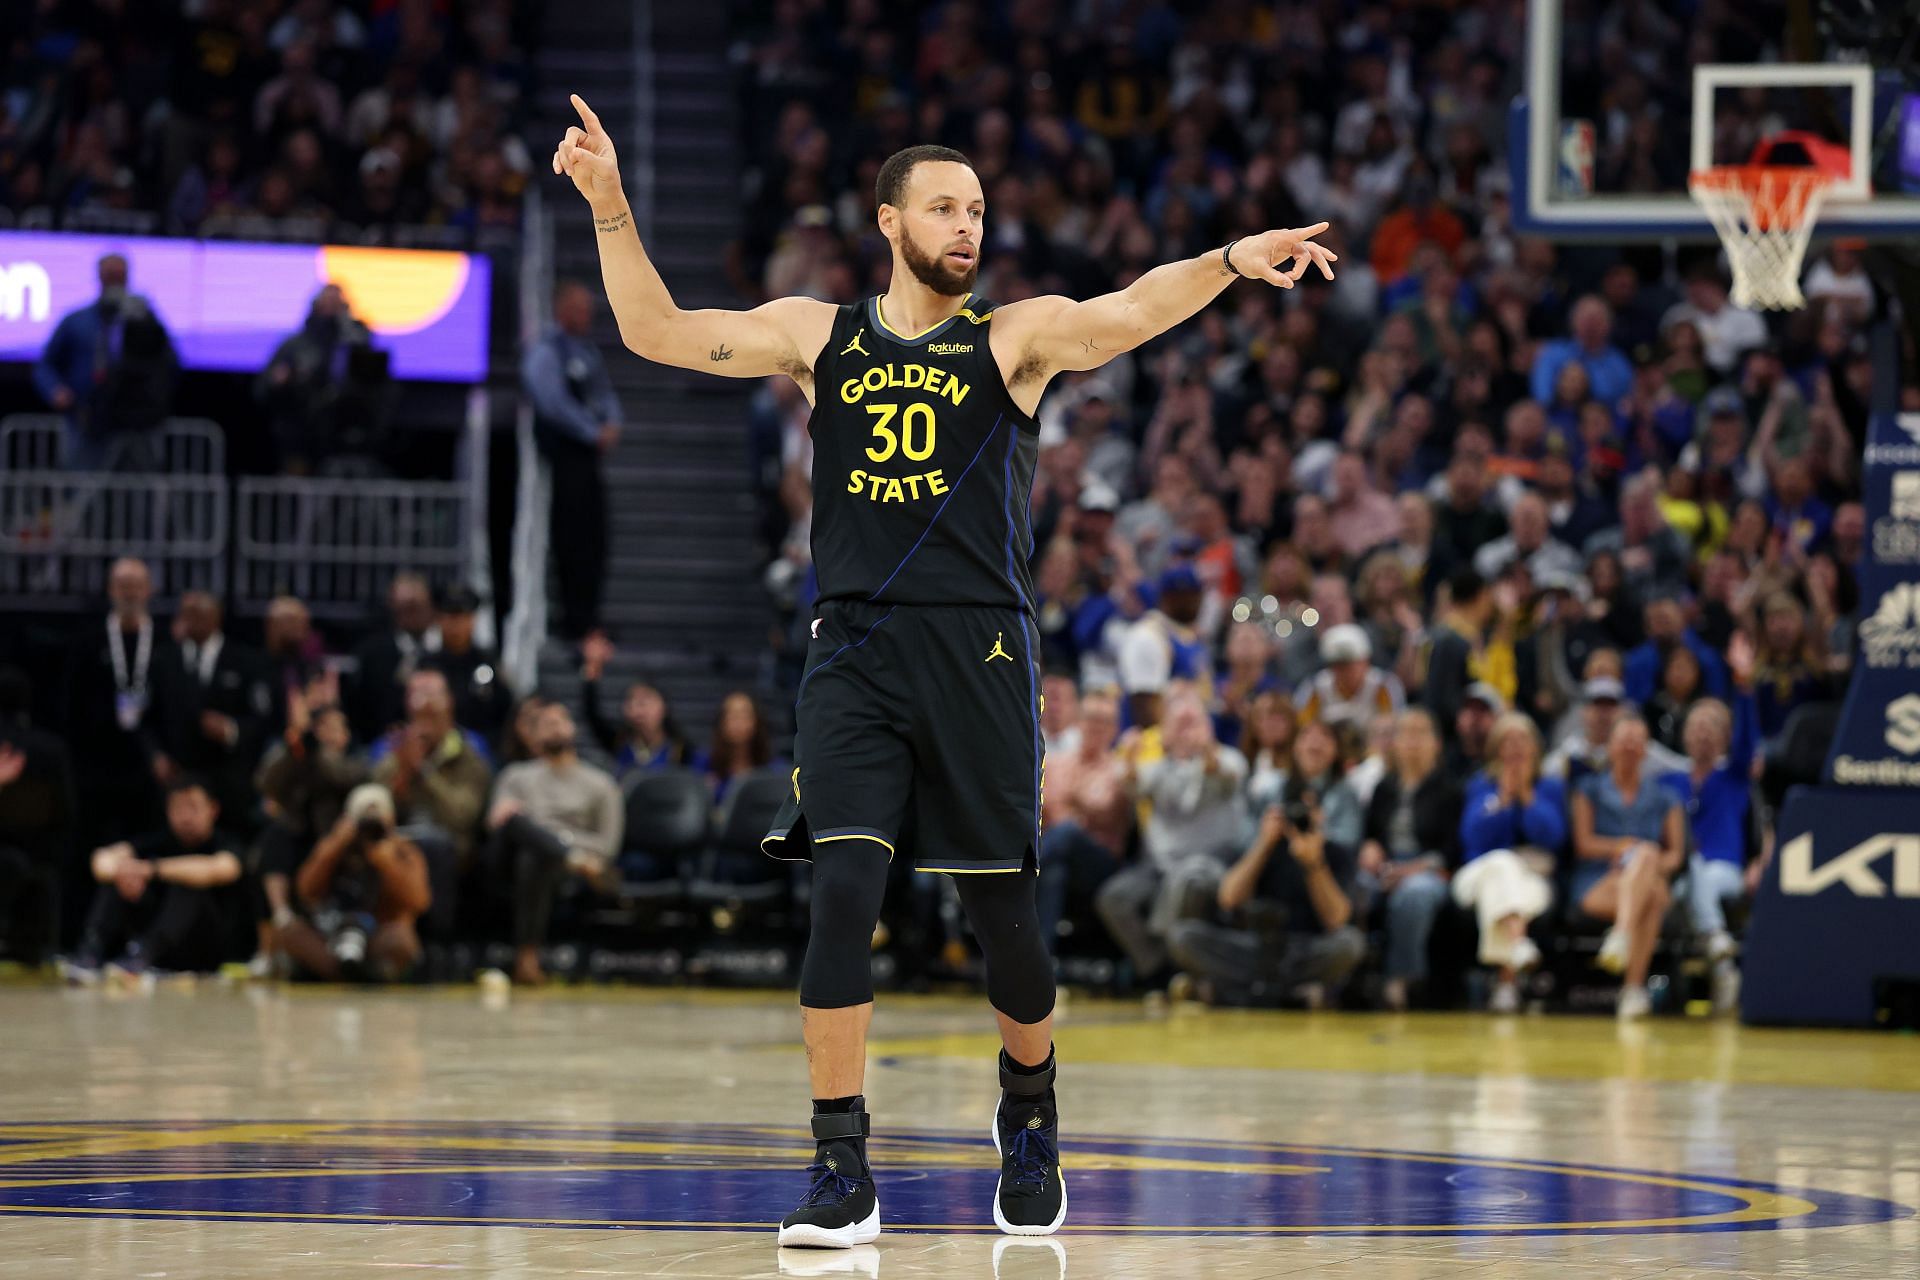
[1688,165,1832,311]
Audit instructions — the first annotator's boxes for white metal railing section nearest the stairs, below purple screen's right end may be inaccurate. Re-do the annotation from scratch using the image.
[234,476,470,618]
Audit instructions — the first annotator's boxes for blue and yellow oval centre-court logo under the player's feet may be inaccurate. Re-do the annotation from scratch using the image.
[0,1121,1914,1236]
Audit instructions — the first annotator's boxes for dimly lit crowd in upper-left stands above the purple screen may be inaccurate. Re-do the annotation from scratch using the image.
[0,0,534,240]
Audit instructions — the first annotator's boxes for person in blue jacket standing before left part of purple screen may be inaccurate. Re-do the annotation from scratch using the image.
[33,253,180,470]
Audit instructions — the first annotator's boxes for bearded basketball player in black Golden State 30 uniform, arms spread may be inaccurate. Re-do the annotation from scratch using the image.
[553,96,1334,1247]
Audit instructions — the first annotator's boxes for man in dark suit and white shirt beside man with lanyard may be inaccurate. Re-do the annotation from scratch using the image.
[154,591,273,835]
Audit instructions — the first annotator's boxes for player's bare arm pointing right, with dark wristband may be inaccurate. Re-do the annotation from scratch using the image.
[996,223,1338,376]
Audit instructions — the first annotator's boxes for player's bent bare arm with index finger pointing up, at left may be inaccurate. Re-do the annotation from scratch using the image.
[553,94,833,386]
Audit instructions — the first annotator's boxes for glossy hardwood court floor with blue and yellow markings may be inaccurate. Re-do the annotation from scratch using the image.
[0,984,1920,1280]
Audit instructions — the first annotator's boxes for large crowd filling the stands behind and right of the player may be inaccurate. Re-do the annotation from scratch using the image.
[732,0,1889,1015]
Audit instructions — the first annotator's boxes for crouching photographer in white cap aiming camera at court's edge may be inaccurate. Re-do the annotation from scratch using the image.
[275,783,434,983]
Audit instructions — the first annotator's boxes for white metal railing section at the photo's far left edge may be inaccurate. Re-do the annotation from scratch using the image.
[0,468,228,608]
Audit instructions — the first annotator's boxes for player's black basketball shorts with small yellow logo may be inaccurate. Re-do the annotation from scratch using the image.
[760,601,1043,873]
